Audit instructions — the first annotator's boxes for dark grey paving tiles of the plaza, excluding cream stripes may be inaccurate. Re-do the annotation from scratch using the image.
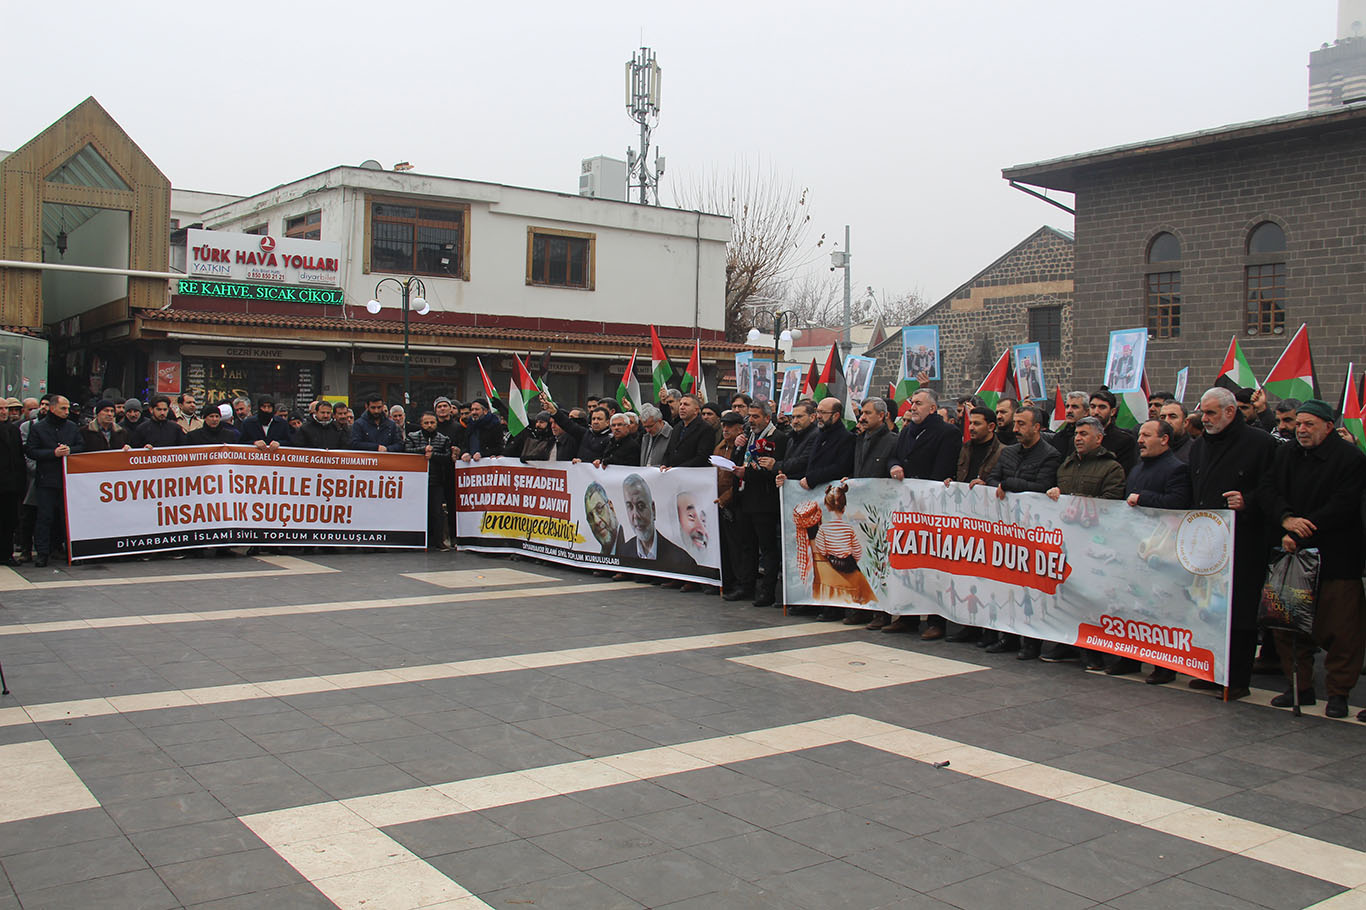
[0,553,1366,910]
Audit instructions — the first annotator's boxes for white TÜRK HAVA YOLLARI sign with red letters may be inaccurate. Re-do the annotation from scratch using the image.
[186,228,342,287]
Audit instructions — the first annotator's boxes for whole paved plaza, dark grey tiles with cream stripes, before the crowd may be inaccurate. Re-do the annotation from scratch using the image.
[0,552,1366,910]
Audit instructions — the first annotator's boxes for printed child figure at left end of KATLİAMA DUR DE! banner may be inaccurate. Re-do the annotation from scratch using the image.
[792,482,877,604]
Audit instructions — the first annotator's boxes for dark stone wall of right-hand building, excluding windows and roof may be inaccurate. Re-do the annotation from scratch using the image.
[1075,127,1366,404]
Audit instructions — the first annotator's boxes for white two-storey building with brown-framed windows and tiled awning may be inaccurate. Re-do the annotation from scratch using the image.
[152,167,744,406]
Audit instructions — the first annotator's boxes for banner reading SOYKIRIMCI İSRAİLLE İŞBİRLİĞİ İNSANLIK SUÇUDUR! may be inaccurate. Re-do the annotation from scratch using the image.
[66,445,428,560]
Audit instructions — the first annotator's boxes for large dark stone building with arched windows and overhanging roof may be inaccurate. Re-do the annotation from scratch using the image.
[1003,105,1366,403]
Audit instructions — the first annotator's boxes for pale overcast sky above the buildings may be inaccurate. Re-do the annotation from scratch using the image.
[0,0,1337,308]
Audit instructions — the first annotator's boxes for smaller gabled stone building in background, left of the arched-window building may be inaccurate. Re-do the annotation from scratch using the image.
[867,225,1072,395]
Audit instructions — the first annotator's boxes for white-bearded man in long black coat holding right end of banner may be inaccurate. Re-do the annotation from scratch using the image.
[1190,388,1280,700]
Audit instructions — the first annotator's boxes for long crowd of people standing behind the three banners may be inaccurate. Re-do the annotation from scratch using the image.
[10,374,1366,720]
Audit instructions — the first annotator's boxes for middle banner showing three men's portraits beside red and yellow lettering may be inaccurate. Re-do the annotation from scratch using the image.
[455,458,721,583]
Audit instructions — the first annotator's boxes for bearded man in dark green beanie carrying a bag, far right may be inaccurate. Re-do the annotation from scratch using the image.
[1262,398,1366,717]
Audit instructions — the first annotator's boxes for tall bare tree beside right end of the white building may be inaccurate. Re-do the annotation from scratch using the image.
[673,163,825,342]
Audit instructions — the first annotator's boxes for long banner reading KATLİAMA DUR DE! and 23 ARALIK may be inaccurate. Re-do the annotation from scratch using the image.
[783,480,1233,683]
